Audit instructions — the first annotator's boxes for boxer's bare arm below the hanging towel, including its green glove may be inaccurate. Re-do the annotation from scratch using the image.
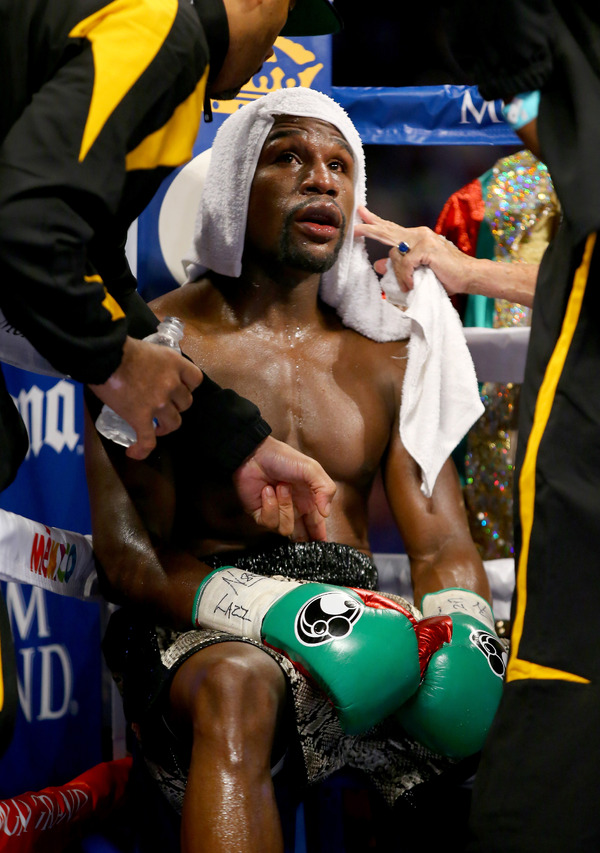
[384,416,506,758]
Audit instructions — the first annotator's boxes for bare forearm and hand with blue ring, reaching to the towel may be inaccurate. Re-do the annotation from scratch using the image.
[355,208,539,308]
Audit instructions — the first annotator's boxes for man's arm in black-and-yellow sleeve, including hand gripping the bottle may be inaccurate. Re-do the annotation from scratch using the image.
[0,3,207,452]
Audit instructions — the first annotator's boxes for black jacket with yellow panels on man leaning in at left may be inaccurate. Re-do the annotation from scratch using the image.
[0,0,269,485]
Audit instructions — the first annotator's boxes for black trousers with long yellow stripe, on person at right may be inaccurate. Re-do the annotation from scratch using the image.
[469,224,600,853]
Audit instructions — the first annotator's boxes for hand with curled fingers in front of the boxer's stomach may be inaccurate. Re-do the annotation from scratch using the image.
[233,436,336,541]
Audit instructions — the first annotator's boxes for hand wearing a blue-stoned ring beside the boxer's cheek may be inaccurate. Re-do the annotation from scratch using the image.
[354,207,473,295]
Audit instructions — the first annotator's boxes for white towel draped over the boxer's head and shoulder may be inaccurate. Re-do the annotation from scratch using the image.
[183,87,483,496]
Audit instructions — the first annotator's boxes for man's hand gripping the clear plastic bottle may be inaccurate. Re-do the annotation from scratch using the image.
[89,338,202,459]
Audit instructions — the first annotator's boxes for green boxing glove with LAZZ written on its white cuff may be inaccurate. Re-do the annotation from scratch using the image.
[192,567,420,734]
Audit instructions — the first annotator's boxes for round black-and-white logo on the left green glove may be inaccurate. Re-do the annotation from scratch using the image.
[295,592,365,646]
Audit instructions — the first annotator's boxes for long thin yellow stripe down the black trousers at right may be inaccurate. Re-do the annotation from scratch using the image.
[506,234,596,684]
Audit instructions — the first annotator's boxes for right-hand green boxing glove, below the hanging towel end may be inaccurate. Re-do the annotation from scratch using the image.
[395,589,508,759]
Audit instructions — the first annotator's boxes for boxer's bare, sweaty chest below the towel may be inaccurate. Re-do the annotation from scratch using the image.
[184,330,394,485]
